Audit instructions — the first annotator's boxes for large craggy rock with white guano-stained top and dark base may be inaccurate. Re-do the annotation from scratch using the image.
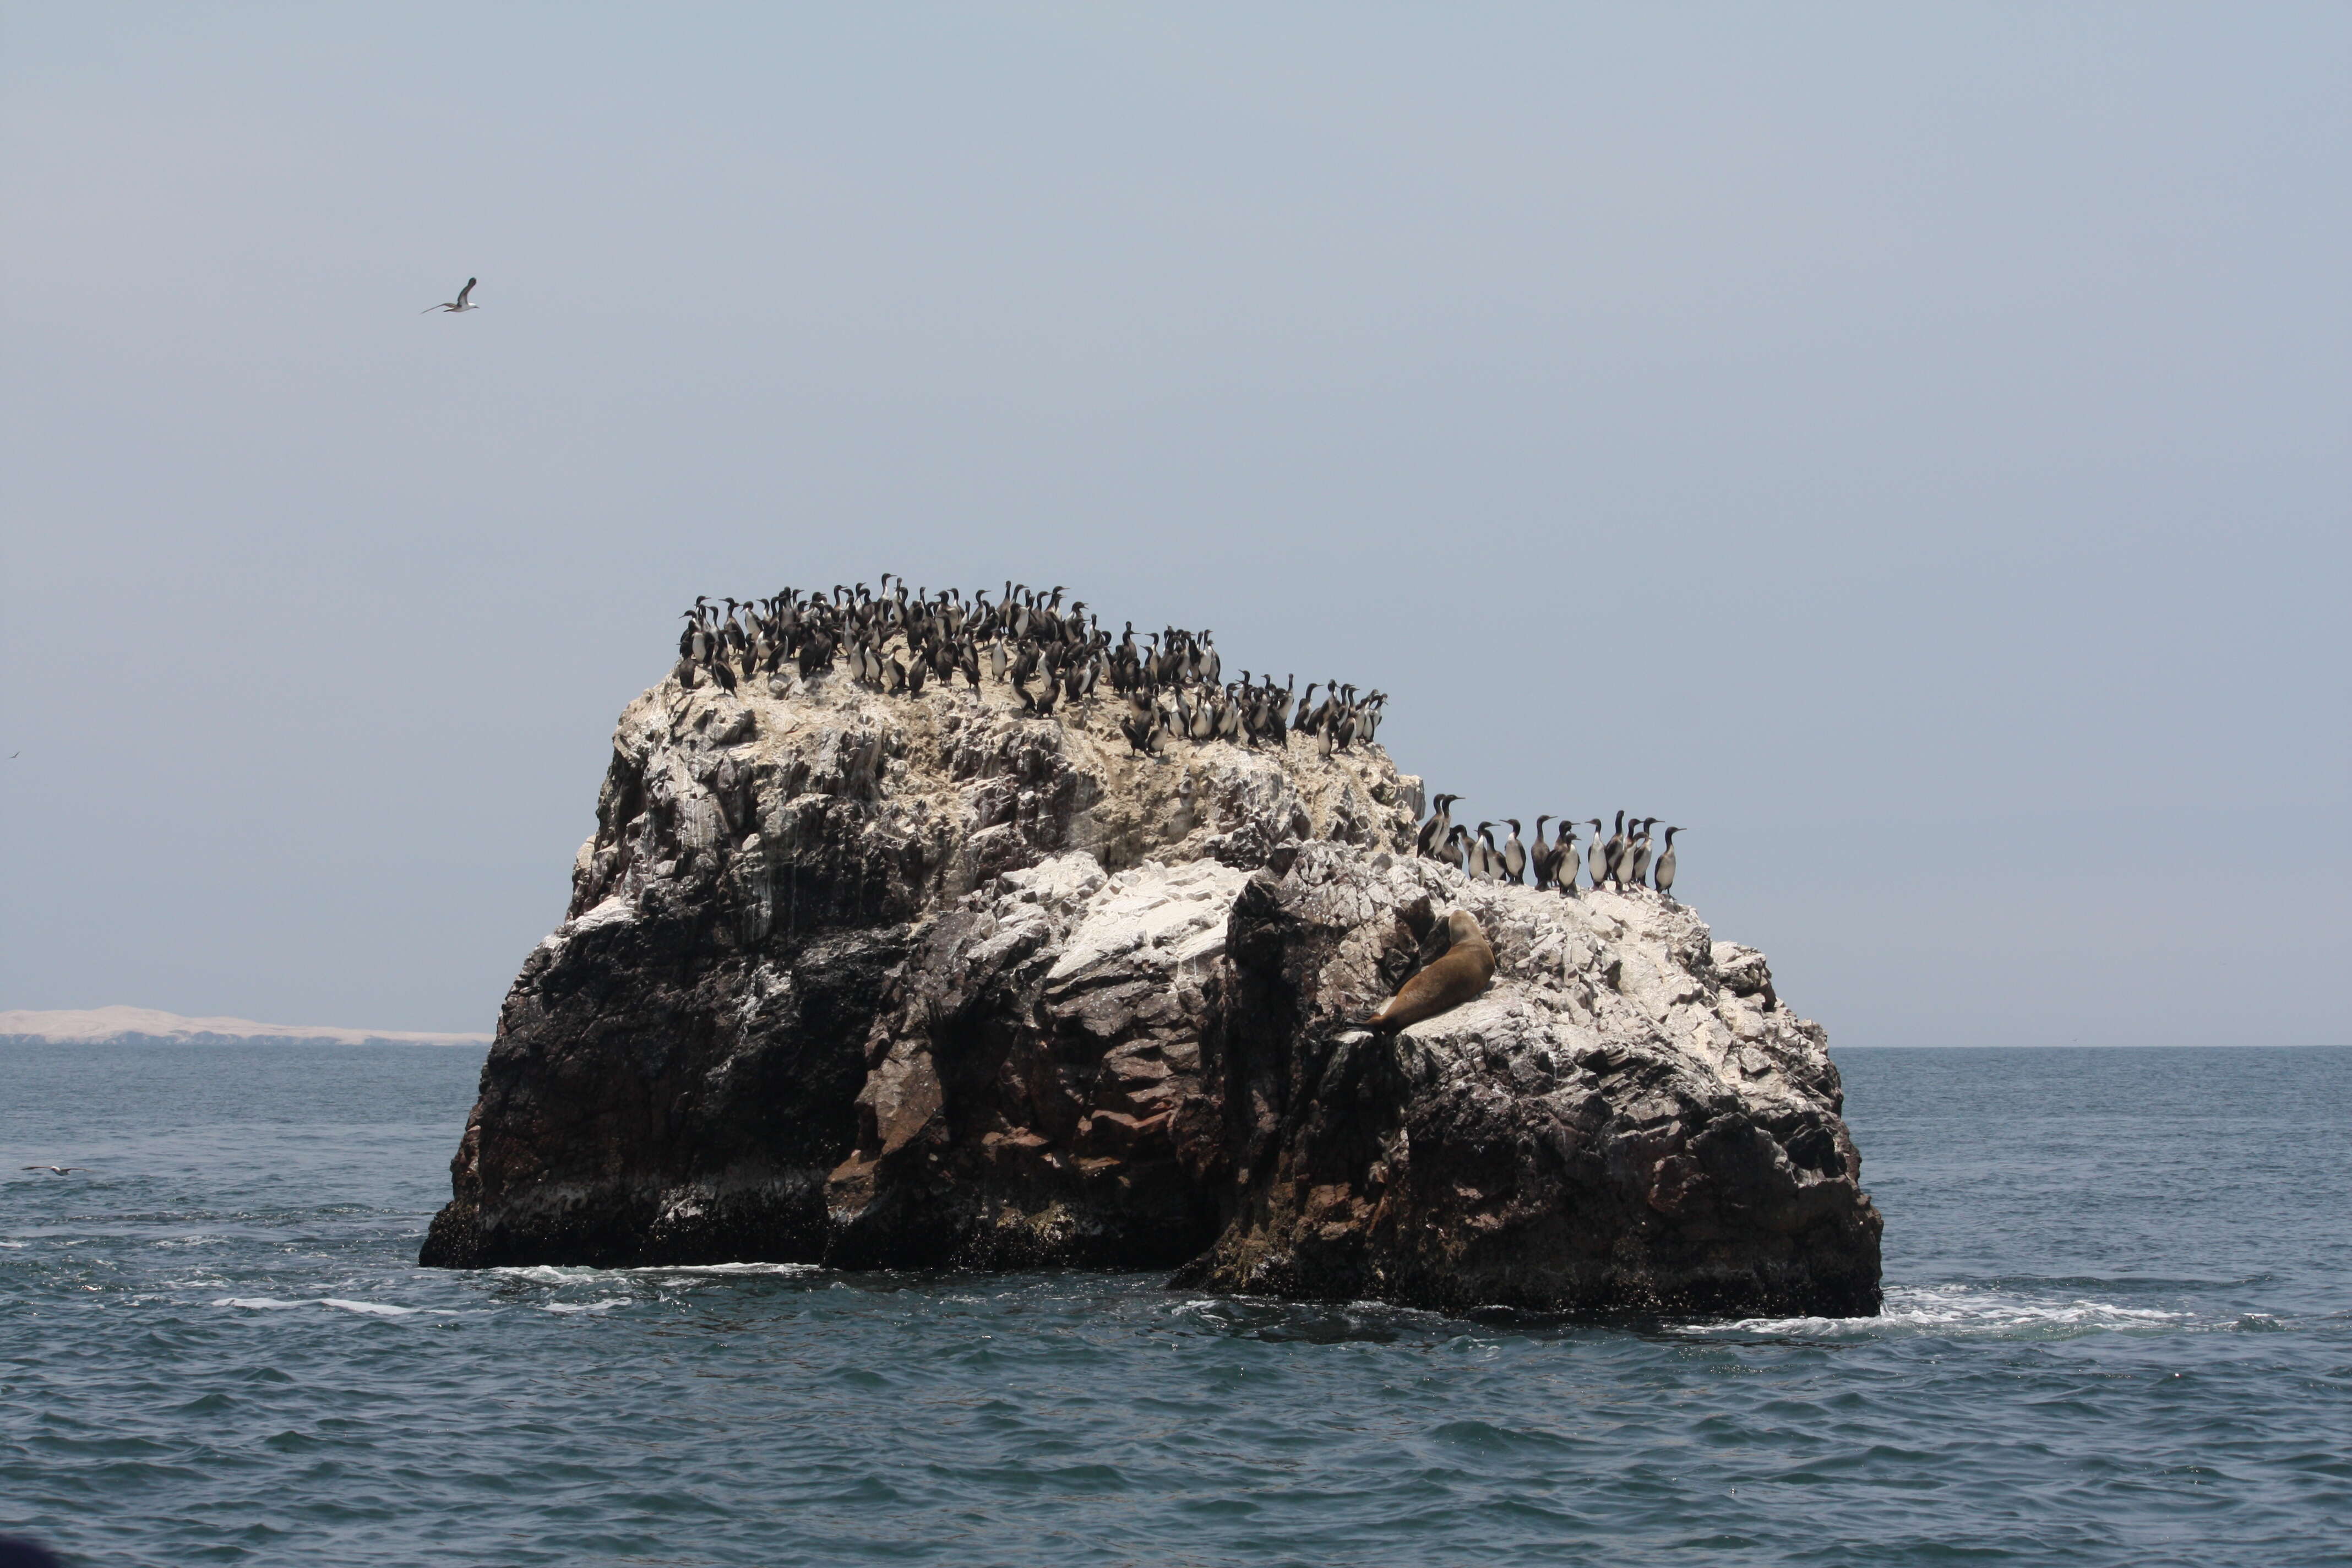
[423,674,1879,1314]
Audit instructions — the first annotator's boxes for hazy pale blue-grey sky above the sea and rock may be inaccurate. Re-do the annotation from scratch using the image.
[0,5,2352,1046]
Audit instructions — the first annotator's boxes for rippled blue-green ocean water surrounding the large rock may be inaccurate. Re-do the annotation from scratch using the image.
[0,1046,2352,1568]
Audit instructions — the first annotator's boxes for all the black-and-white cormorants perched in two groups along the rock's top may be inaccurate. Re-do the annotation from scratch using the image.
[673,571,1681,898]
